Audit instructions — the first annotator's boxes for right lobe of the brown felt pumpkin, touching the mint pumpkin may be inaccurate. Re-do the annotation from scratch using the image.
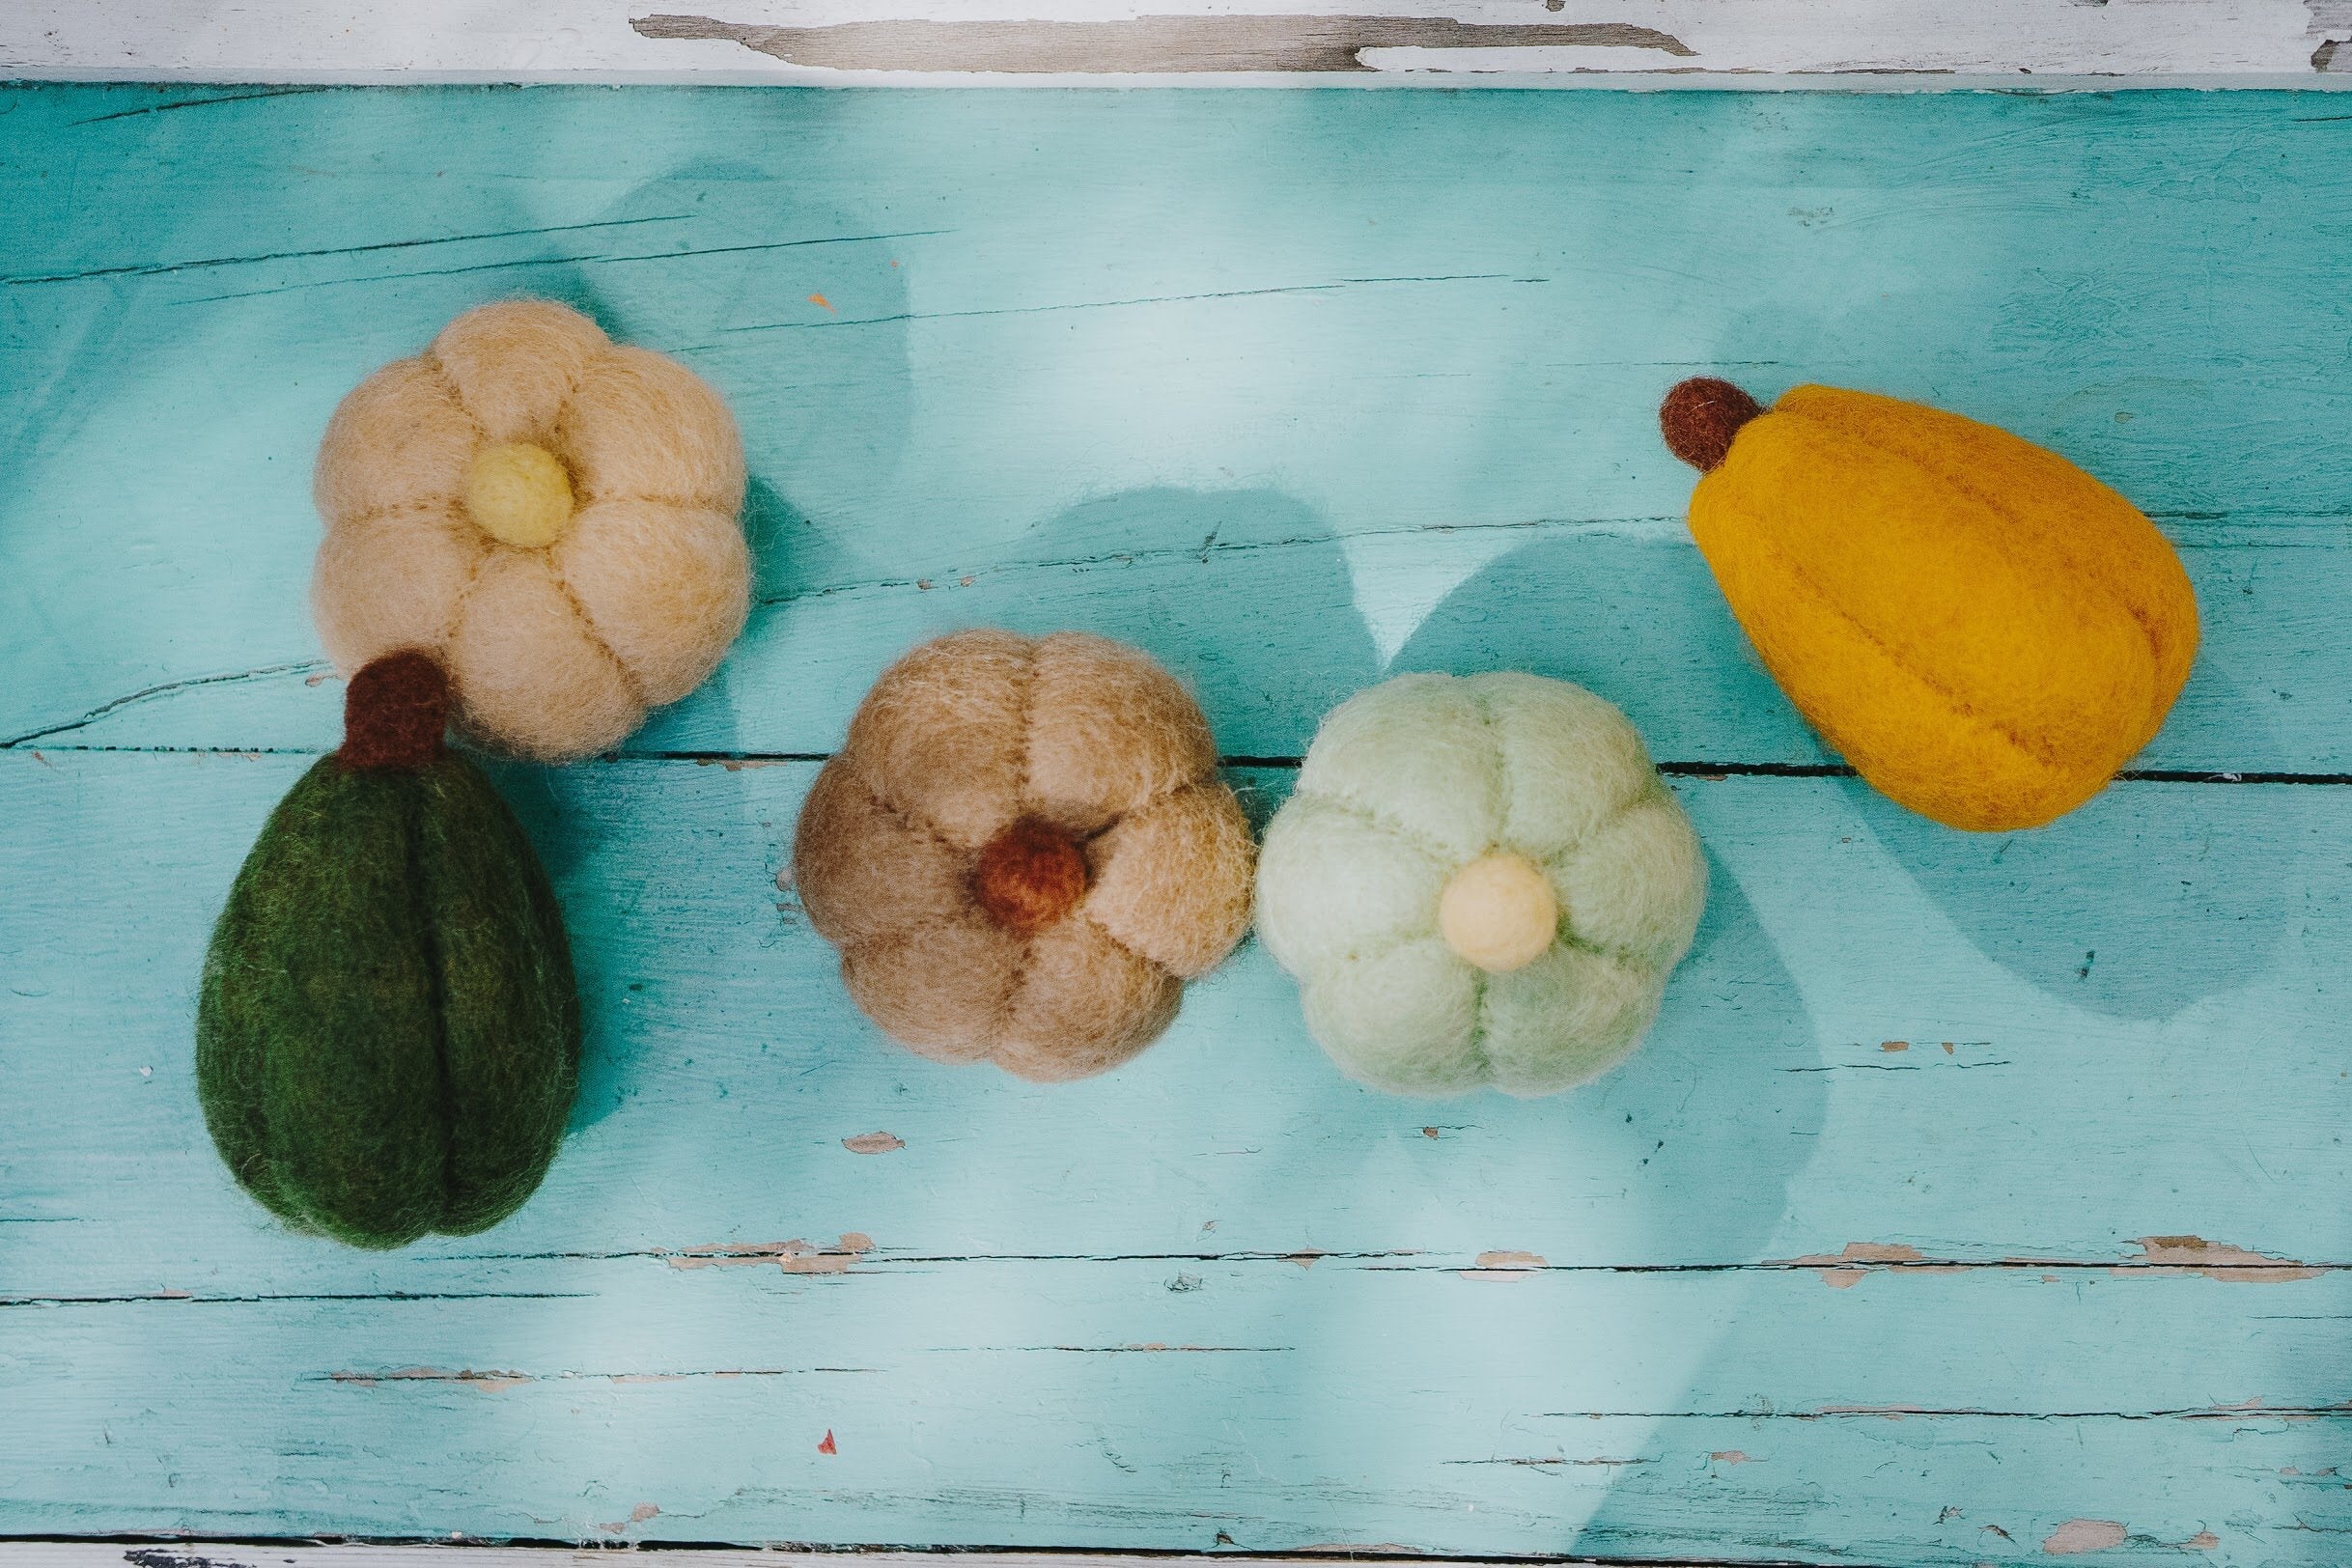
[1086,780,1256,980]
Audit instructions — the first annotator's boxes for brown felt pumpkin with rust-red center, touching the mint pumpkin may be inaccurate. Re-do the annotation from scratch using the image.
[793,630,1253,1081]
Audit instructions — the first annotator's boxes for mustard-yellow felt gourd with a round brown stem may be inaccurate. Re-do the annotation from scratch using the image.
[1658,378,2197,832]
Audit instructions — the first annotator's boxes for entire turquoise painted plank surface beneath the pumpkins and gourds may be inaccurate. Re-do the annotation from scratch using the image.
[0,90,2352,1563]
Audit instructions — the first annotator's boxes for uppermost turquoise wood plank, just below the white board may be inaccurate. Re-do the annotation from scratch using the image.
[0,90,2352,771]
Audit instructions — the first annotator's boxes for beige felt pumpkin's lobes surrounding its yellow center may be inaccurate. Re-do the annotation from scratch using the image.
[311,301,750,762]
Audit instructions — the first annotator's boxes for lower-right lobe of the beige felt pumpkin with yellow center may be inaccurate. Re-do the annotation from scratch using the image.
[550,501,750,703]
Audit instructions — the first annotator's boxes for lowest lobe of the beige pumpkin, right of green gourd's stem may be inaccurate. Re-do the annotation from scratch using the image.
[444,550,644,762]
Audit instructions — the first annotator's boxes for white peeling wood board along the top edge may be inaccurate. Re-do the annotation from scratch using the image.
[0,0,2352,90]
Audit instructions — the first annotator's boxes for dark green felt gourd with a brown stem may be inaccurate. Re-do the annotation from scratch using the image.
[195,651,581,1248]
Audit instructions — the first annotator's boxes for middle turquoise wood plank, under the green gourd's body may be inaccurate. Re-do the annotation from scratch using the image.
[0,752,2352,1296]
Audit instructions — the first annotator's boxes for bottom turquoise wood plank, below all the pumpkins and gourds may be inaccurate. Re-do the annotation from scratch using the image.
[0,1260,2352,1563]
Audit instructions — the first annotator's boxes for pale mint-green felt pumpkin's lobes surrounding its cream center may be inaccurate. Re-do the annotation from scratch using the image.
[1258,672,1708,1096]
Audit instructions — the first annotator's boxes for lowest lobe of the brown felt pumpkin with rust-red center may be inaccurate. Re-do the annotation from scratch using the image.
[991,917,1183,1083]
